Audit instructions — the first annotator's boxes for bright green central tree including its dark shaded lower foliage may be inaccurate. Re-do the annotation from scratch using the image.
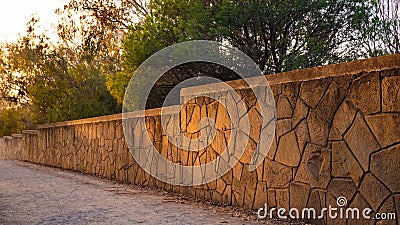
[106,0,240,105]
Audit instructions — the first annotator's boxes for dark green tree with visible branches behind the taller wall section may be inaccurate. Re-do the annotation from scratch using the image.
[212,0,378,74]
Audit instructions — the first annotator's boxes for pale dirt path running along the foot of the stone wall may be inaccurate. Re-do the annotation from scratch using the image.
[0,160,289,224]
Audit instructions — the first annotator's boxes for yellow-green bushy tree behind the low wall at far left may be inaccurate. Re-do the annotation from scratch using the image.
[1,16,120,123]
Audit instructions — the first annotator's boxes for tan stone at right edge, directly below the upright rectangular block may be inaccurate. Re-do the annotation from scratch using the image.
[365,114,400,148]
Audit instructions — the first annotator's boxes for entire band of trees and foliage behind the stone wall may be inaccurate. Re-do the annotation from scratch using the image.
[0,0,400,129]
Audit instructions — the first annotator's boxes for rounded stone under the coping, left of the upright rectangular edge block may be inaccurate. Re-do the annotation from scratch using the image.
[349,72,381,114]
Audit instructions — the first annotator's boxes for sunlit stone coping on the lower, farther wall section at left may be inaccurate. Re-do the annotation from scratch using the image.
[38,105,180,129]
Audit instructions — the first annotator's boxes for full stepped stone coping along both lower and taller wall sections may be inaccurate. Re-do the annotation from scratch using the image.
[38,54,400,129]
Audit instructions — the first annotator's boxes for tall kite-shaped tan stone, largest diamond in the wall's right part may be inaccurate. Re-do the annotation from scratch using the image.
[345,113,380,171]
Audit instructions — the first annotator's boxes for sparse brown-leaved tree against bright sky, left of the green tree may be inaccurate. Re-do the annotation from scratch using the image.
[56,0,149,74]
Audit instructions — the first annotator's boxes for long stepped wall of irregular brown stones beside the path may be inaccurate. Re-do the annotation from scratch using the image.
[0,55,400,224]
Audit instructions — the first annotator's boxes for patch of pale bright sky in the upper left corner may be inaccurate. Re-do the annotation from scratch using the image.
[0,0,64,42]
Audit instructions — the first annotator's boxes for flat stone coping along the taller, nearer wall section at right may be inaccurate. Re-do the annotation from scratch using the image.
[181,54,400,96]
